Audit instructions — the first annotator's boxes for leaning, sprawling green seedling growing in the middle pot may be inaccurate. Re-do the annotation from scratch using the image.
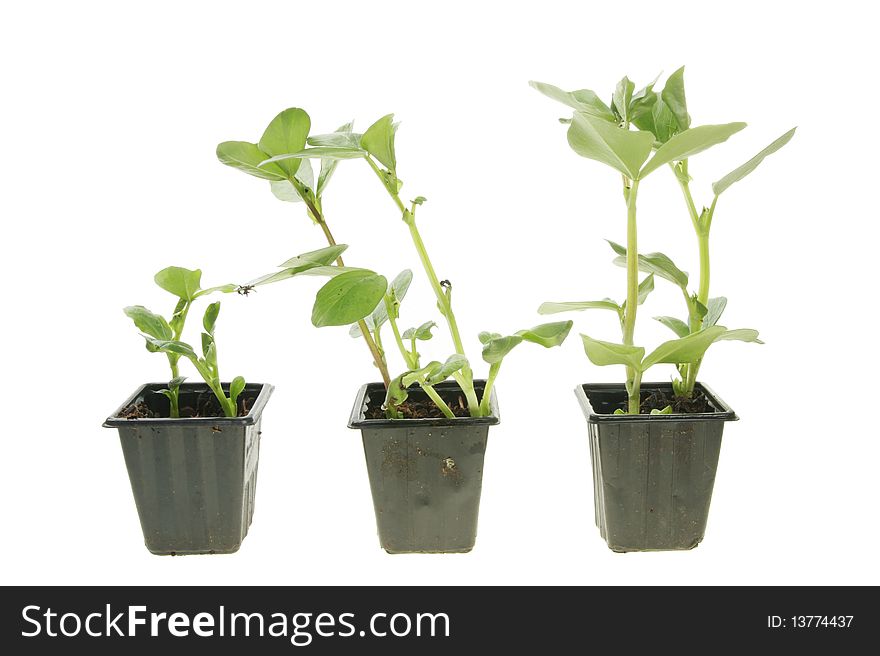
[225,110,572,418]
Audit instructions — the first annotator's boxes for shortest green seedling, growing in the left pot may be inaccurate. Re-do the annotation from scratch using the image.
[123,267,239,419]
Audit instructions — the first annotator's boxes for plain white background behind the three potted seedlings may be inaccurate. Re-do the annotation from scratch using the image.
[0,0,880,585]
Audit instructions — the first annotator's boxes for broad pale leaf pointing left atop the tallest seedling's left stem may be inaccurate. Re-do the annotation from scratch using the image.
[568,113,654,179]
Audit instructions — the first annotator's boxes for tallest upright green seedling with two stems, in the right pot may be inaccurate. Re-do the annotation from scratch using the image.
[531,68,794,414]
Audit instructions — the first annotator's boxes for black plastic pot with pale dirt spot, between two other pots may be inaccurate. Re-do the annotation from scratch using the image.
[348,380,499,554]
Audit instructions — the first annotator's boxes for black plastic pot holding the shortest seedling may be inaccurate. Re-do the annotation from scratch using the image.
[104,383,273,556]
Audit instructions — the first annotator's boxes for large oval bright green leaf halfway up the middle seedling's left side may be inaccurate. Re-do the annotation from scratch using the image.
[312,270,388,328]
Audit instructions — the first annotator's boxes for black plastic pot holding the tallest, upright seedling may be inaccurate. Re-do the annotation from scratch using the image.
[575,383,737,552]
